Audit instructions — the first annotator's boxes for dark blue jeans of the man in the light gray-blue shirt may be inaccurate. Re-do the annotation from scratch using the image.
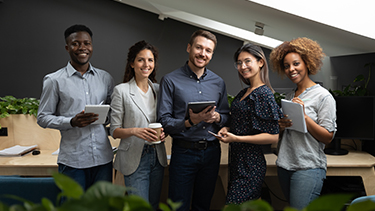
[58,162,113,190]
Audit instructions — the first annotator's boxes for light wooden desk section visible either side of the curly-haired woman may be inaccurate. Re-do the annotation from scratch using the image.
[266,151,375,195]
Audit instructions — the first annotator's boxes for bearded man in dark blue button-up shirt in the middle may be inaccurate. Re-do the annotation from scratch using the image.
[158,30,229,210]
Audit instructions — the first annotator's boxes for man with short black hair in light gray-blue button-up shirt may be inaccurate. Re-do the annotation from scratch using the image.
[37,25,114,189]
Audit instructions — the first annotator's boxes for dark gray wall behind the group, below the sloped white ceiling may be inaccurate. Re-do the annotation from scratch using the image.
[0,0,375,98]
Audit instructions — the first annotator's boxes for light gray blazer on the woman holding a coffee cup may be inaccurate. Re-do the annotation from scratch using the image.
[110,78,167,175]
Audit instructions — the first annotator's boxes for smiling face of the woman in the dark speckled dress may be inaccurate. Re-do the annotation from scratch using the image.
[236,51,264,80]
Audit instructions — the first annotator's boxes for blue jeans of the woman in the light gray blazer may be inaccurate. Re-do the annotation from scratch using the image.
[124,144,164,210]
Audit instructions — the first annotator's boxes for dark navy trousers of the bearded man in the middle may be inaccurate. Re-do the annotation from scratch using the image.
[169,145,221,211]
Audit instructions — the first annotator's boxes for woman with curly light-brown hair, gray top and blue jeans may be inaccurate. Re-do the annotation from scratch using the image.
[270,38,336,210]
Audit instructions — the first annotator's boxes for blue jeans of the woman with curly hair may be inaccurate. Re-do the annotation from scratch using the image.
[277,167,326,210]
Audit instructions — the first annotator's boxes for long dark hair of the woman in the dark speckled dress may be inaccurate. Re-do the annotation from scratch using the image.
[233,43,274,92]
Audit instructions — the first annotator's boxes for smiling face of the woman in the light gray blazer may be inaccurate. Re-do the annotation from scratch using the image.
[131,49,155,79]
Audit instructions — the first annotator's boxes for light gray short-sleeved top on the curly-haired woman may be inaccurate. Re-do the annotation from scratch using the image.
[276,84,336,171]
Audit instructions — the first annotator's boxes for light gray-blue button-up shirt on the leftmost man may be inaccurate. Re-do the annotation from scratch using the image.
[37,63,114,168]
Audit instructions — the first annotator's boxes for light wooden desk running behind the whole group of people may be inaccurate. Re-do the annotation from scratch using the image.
[0,144,375,195]
